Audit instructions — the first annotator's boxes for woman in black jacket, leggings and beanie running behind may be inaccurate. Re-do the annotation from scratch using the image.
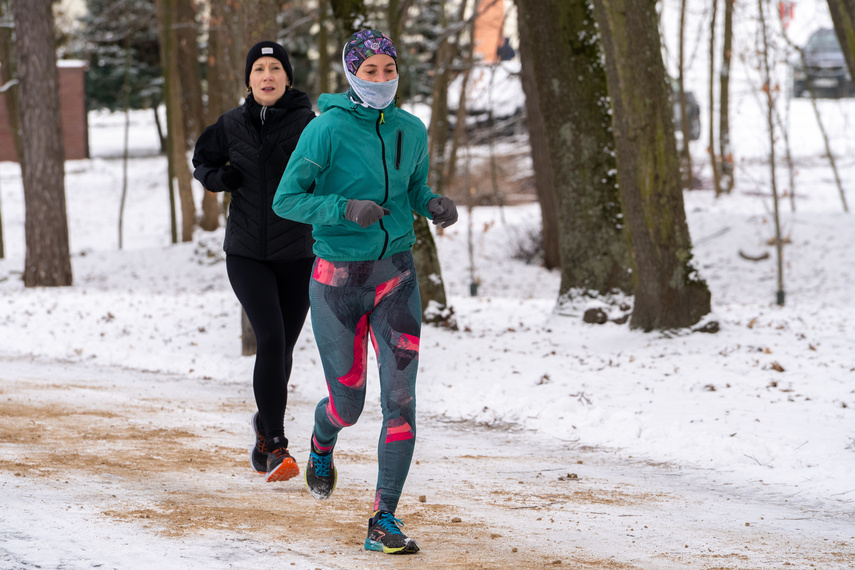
[193,41,315,482]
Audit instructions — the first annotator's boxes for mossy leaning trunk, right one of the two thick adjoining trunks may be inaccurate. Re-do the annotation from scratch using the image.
[594,0,710,331]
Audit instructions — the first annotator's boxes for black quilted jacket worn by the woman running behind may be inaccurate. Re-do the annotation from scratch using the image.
[193,89,315,261]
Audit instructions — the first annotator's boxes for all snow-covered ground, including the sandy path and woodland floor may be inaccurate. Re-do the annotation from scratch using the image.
[0,3,855,569]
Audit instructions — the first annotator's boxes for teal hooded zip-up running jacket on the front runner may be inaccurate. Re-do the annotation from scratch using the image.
[273,93,437,261]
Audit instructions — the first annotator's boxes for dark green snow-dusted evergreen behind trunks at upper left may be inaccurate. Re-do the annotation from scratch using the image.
[77,0,163,110]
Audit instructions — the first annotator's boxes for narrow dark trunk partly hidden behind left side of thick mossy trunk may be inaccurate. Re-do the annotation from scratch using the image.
[517,0,561,269]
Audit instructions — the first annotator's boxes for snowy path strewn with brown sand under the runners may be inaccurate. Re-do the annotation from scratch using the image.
[0,359,855,570]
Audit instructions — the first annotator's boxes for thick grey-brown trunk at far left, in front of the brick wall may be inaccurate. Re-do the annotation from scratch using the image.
[12,0,72,287]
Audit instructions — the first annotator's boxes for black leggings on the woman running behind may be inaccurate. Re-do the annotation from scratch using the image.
[226,255,314,447]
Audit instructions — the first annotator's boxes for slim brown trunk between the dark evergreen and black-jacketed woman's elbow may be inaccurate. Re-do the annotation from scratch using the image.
[157,0,196,242]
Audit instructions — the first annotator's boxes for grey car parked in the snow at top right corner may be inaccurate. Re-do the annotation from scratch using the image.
[792,28,855,98]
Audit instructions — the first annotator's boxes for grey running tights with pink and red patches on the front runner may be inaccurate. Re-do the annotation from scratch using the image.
[309,251,421,513]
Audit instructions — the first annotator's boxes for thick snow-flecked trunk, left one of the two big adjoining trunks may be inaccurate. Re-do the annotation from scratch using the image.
[518,0,628,292]
